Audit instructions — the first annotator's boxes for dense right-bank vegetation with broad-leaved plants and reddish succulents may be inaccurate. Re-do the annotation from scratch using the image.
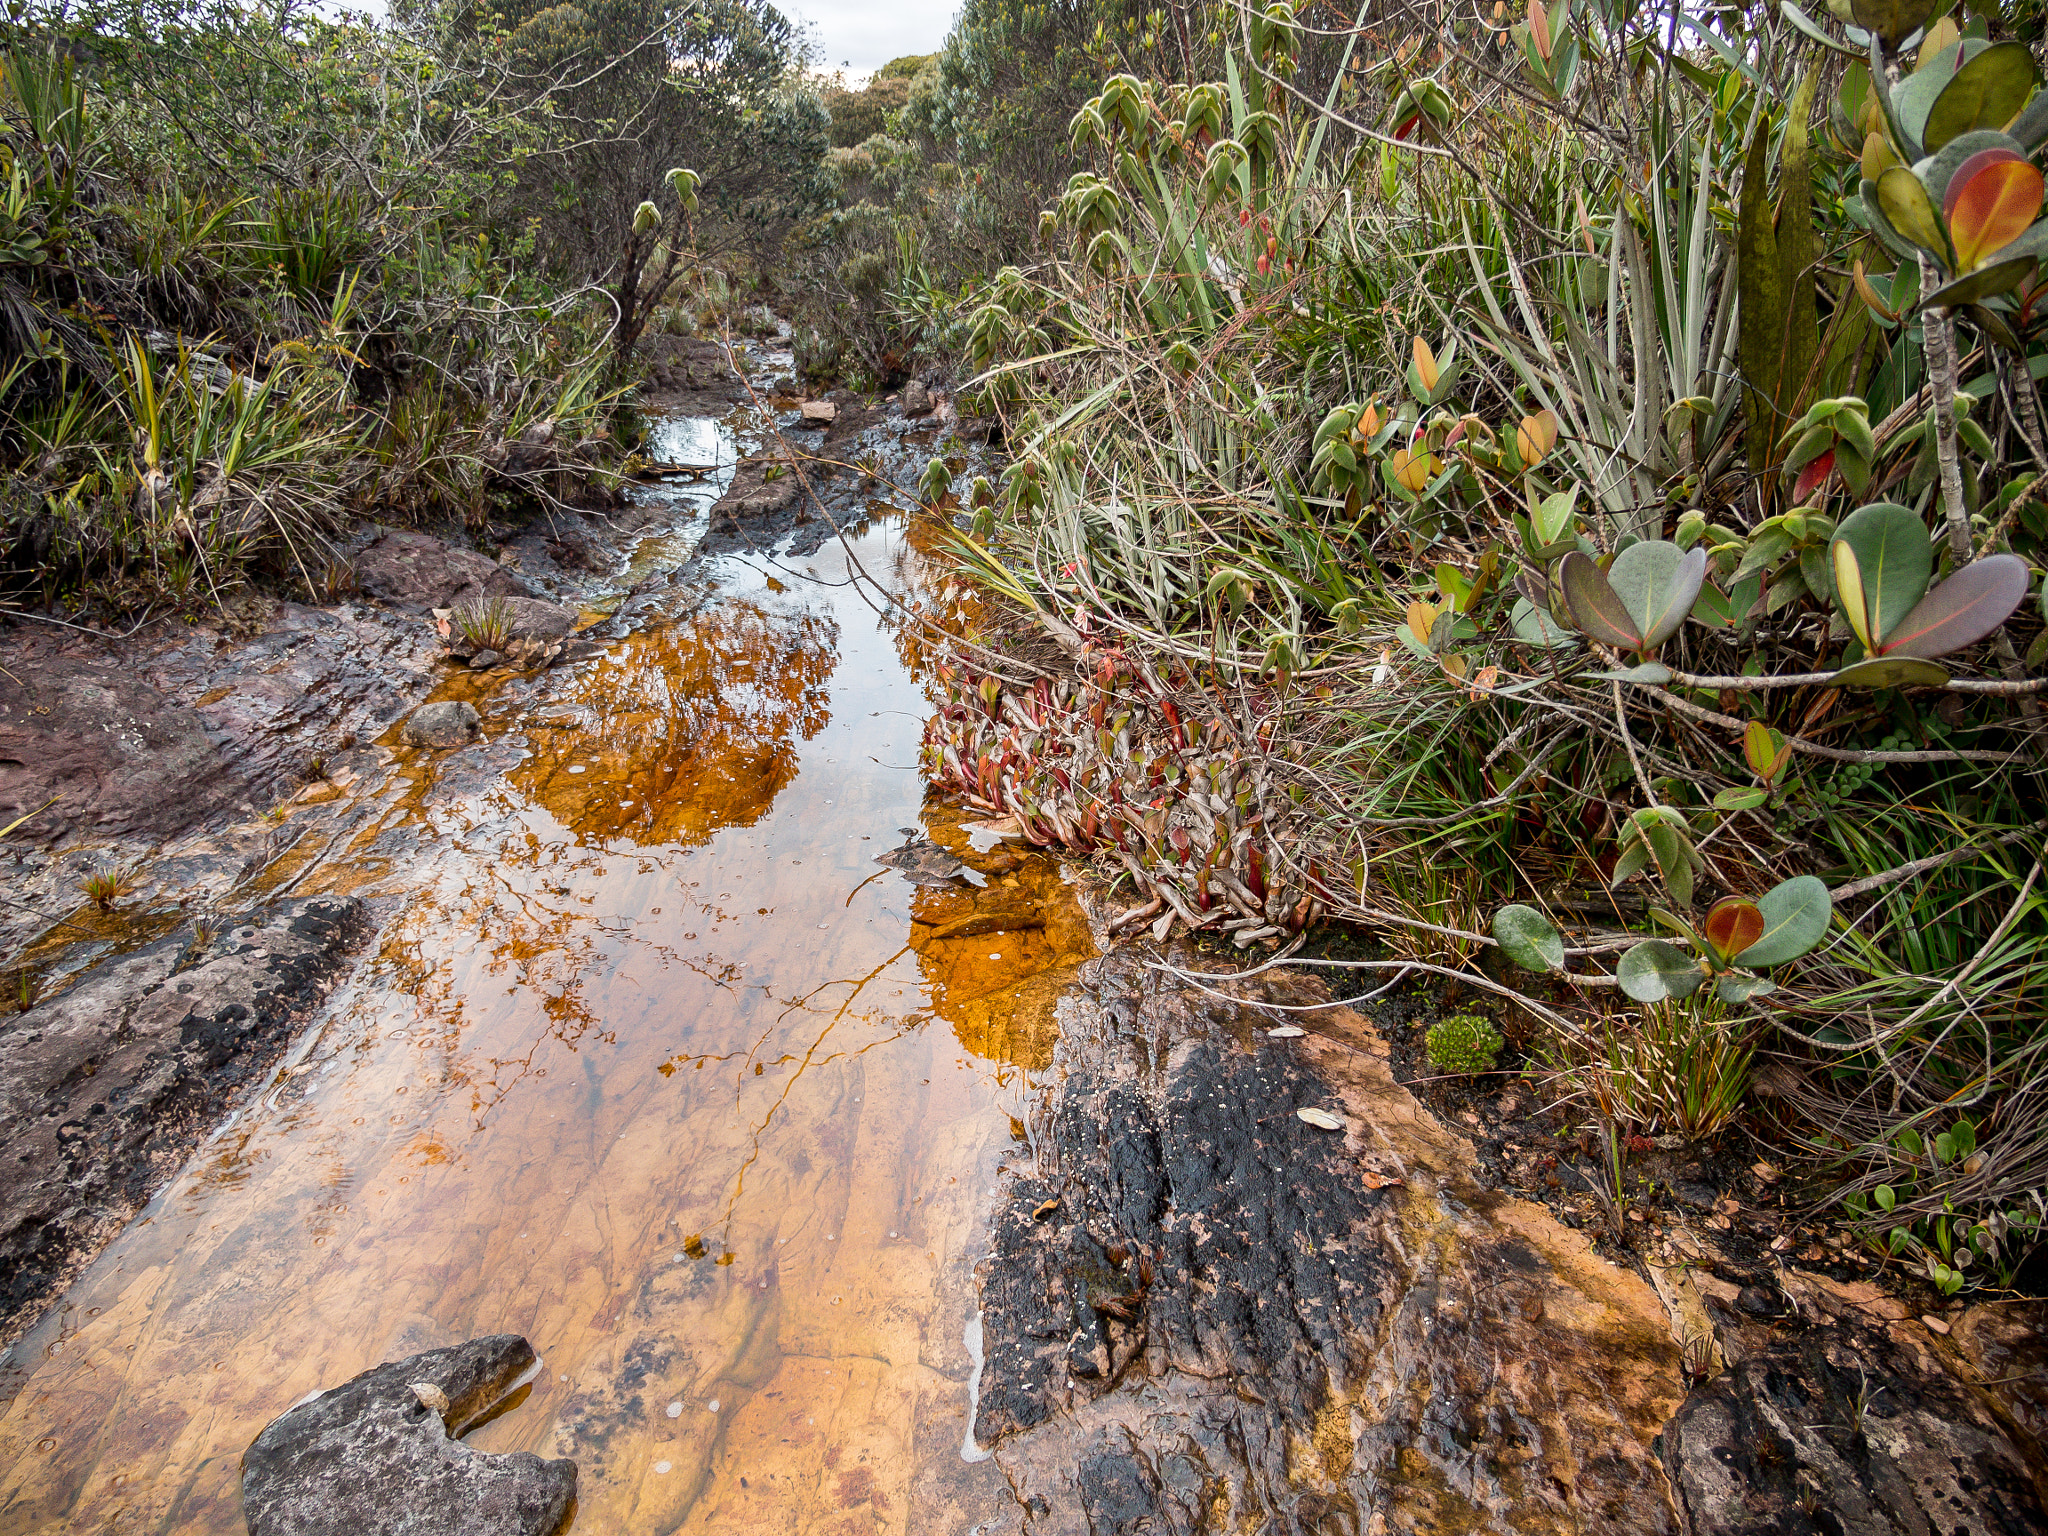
[807,0,2048,1290]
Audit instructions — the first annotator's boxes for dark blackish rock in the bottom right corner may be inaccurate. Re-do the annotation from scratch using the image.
[1661,1321,2048,1536]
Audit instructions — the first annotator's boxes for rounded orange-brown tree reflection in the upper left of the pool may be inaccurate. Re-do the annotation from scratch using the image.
[512,600,838,846]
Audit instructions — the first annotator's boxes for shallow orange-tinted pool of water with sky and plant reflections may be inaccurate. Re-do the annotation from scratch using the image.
[0,454,1090,1536]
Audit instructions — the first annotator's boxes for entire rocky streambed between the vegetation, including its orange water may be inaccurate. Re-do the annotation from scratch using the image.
[0,376,2048,1536]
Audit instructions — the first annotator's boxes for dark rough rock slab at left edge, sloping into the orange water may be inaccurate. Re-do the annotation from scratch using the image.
[0,897,362,1339]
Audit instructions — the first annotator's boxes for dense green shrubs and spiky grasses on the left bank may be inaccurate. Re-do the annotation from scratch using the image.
[0,0,827,610]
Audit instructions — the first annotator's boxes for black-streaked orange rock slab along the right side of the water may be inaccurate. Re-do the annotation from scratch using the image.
[977,952,1683,1536]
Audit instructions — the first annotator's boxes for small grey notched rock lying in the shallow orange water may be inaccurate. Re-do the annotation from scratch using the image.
[242,1333,575,1536]
